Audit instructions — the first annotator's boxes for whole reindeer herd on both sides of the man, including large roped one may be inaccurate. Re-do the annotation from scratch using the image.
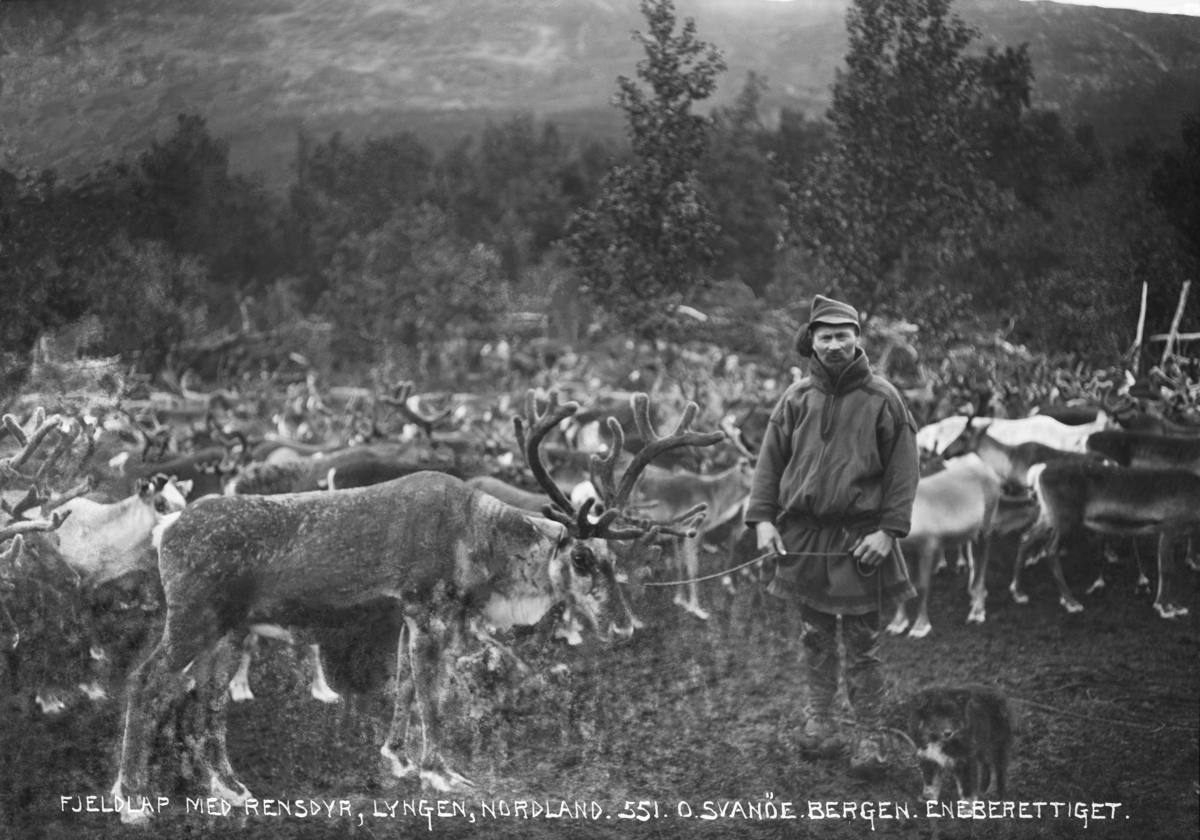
[0,369,1200,822]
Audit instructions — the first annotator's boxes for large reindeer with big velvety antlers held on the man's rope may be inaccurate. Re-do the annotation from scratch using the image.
[112,391,720,822]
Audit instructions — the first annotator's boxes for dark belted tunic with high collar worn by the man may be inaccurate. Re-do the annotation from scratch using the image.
[745,349,919,616]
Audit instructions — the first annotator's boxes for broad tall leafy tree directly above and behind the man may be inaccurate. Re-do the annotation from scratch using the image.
[792,0,1032,317]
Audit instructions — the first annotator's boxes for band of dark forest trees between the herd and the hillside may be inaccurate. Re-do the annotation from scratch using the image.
[0,0,1200,408]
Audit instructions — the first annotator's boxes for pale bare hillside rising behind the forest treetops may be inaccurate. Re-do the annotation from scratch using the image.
[0,0,1200,185]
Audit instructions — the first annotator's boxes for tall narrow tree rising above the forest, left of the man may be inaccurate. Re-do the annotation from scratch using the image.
[568,0,725,335]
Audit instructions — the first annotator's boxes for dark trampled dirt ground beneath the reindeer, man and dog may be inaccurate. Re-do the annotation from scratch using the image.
[0,535,1200,840]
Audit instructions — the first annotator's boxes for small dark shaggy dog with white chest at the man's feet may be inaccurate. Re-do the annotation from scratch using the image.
[908,685,1013,800]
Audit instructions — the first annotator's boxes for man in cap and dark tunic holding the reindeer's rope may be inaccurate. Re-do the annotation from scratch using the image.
[745,295,918,775]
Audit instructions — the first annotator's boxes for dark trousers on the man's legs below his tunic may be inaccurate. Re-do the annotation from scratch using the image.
[800,604,883,728]
